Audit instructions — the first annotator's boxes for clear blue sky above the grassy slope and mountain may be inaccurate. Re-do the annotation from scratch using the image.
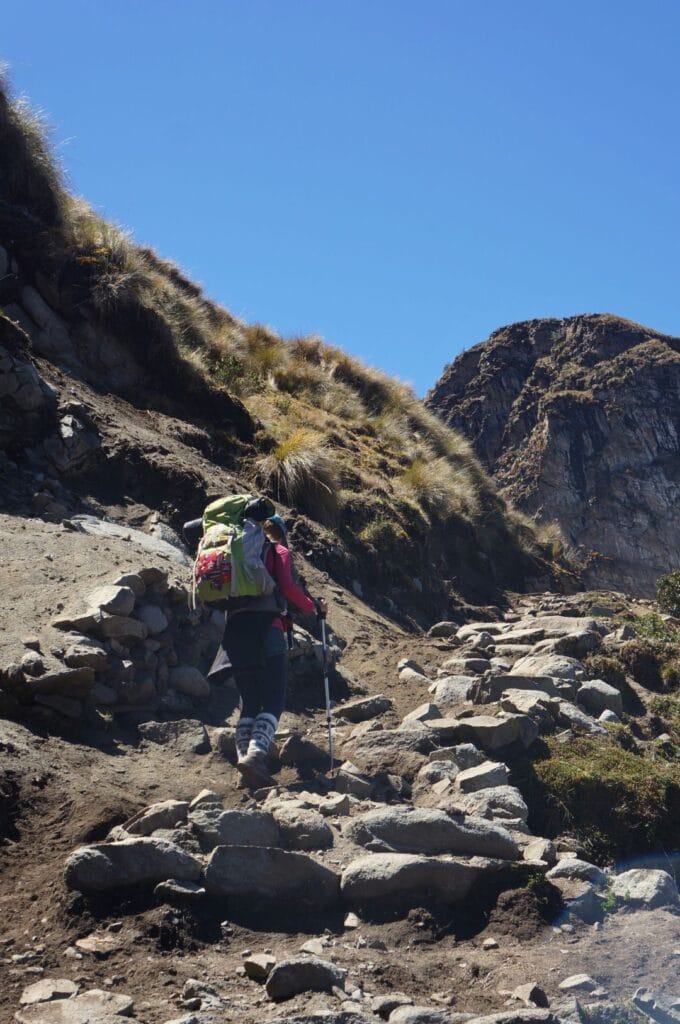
[0,0,680,393]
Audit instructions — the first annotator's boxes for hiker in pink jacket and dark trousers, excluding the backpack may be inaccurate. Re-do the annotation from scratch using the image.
[195,499,328,786]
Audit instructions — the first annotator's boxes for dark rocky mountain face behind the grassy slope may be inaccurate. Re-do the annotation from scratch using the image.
[426,314,680,594]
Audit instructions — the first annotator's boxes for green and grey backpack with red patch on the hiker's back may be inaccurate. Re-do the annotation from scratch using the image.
[194,495,275,604]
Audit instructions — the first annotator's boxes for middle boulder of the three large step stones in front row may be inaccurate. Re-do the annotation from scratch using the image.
[205,846,340,908]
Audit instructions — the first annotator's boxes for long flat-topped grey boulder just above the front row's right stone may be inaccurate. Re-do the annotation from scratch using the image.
[344,807,519,860]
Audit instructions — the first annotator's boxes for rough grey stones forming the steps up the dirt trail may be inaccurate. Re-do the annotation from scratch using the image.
[54,593,679,1024]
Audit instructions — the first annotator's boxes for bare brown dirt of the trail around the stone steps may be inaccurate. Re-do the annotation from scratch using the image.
[0,536,680,1024]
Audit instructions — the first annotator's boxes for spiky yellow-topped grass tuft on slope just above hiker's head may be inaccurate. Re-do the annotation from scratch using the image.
[257,428,338,525]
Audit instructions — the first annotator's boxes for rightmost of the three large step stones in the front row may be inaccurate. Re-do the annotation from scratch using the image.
[341,853,496,905]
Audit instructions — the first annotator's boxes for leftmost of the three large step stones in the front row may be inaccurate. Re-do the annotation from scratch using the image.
[63,838,201,893]
